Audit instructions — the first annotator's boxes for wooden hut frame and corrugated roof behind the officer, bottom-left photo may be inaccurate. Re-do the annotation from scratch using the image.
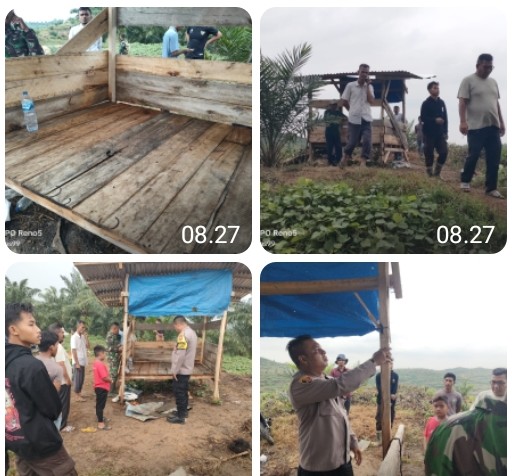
[75,263,252,400]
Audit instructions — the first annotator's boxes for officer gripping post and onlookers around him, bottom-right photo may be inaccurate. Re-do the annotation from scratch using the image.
[287,335,507,476]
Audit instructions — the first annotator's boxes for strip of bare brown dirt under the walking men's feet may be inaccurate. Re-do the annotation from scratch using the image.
[260,152,507,217]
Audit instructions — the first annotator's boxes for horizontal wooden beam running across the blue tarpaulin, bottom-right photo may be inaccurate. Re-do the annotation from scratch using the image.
[260,278,379,296]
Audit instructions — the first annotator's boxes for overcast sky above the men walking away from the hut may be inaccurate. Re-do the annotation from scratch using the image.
[260,6,507,144]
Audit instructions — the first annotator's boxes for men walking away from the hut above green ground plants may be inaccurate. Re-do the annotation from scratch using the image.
[324,57,505,198]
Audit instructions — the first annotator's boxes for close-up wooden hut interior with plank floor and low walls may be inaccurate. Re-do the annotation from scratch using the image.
[5,7,252,253]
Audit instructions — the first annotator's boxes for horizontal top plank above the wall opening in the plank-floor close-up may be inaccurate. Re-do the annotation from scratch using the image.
[118,7,252,28]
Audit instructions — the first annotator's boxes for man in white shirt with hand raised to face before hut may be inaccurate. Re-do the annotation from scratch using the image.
[340,64,377,167]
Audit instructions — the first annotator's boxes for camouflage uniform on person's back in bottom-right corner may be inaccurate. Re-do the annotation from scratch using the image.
[425,398,507,476]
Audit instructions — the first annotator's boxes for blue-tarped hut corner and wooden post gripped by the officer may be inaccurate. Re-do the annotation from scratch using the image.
[260,263,402,462]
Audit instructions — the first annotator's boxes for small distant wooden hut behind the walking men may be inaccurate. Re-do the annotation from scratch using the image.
[308,71,423,163]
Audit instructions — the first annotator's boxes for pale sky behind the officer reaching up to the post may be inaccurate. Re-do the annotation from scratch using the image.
[260,256,510,370]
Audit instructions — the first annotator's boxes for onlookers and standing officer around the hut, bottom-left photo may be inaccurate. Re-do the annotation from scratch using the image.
[5,303,197,476]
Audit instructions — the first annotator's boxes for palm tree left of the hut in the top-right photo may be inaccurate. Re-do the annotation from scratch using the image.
[260,43,322,167]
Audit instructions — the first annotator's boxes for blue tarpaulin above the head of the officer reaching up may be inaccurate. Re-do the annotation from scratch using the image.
[260,263,379,338]
